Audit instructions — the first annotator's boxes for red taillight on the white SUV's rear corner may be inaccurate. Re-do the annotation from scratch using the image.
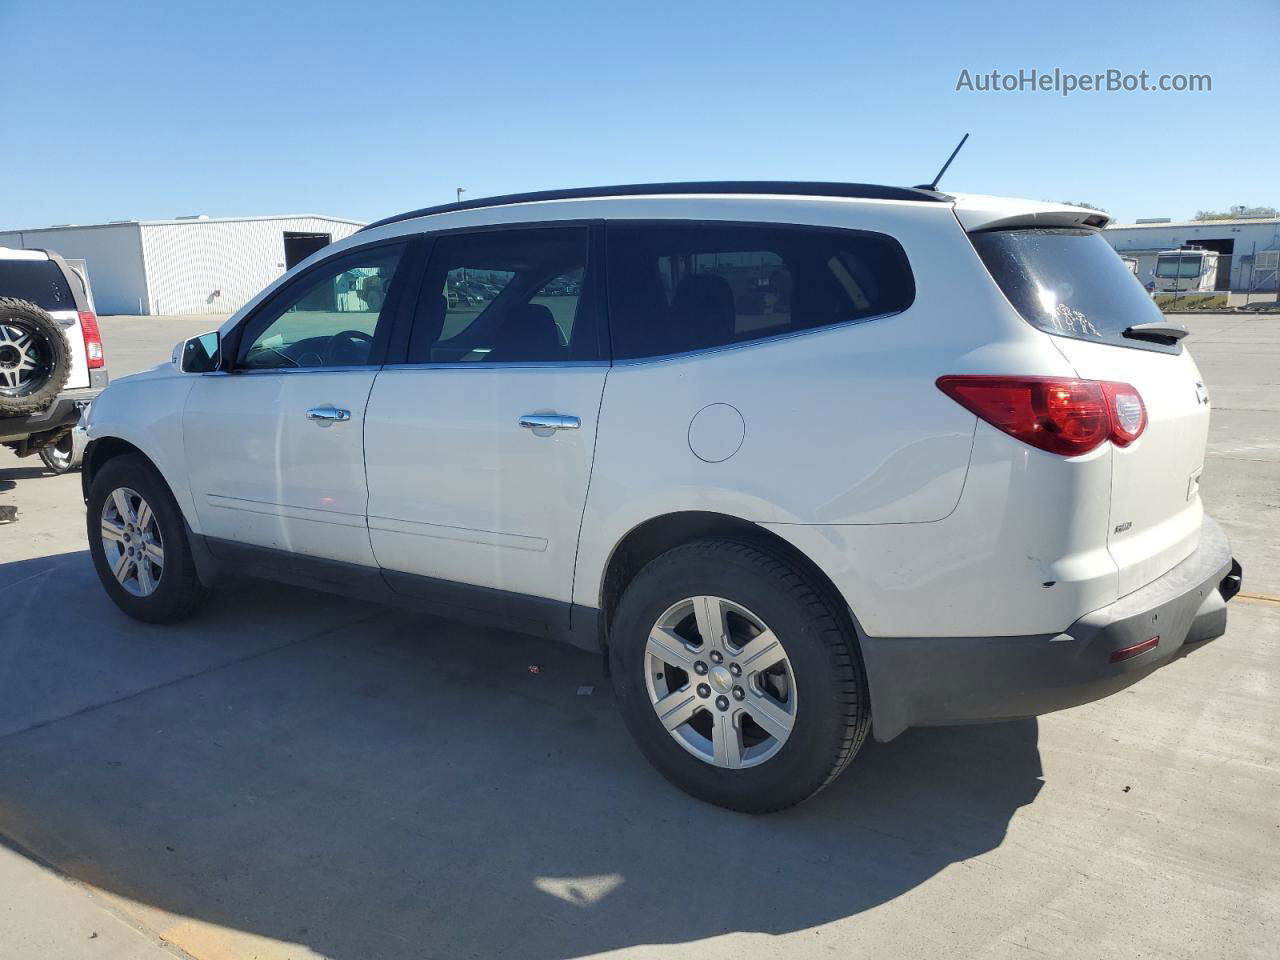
[938,376,1147,457]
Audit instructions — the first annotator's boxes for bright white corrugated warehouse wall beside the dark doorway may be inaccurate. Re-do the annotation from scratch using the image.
[140,216,360,314]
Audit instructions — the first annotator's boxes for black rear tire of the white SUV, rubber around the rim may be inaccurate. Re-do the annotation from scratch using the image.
[609,540,870,813]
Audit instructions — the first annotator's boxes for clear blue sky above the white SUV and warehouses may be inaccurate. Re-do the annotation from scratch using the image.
[0,0,1280,228]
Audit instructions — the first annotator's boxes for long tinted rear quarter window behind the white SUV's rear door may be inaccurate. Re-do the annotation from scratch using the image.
[608,223,915,360]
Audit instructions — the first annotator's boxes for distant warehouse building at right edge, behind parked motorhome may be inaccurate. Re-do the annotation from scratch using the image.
[1102,216,1280,293]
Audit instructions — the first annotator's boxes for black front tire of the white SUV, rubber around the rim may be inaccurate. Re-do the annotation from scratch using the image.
[86,454,206,623]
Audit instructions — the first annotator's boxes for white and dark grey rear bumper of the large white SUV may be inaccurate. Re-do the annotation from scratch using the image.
[861,516,1240,740]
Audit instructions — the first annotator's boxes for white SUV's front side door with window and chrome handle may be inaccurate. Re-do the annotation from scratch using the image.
[183,243,406,567]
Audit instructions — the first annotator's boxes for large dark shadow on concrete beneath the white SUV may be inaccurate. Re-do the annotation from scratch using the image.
[0,552,1041,960]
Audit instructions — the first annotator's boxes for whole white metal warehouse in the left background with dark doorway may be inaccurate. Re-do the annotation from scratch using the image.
[0,214,362,315]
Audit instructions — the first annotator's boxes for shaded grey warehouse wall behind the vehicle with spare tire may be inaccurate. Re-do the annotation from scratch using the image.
[0,223,148,314]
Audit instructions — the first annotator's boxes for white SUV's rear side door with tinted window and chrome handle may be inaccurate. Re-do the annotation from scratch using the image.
[365,224,608,627]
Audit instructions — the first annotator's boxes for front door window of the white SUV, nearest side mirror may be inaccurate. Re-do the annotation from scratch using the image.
[239,246,404,370]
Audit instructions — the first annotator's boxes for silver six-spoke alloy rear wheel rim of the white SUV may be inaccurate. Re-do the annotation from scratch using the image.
[645,596,796,769]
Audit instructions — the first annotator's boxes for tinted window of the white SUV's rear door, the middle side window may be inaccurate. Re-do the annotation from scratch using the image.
[408,227,600,364]
